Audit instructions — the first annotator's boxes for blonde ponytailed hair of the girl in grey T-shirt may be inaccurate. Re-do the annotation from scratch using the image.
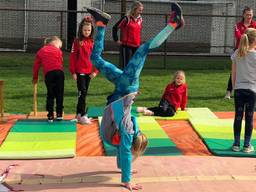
[238,28,256,57]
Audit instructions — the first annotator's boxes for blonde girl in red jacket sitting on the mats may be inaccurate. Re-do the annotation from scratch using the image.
[137,71,188,117]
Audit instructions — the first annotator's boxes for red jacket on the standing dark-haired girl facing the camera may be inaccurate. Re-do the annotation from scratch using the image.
[69,38,98,74]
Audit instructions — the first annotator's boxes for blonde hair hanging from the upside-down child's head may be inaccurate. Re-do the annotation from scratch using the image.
[132,132,148,161]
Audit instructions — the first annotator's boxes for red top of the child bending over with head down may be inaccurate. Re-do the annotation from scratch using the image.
[33,44,63,80]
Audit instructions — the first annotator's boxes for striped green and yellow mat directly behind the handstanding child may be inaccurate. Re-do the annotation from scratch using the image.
[99,116,182,156]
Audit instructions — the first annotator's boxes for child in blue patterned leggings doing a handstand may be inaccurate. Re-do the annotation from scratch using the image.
[87,3,184,191]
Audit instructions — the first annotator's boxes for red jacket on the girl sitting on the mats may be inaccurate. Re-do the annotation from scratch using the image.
[162,82,188,110]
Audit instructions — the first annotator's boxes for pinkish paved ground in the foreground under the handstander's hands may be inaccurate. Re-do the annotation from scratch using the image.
[0,156,256,192]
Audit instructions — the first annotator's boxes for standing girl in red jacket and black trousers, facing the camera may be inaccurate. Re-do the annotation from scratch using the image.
[69,16,98,124]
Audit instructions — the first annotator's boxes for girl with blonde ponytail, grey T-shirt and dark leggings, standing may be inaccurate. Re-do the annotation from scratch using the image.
[231,28,256,153]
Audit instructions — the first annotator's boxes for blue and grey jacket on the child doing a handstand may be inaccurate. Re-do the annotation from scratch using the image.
[100,93,139,182]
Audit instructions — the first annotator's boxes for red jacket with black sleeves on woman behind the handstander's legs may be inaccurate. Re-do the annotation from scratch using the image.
[113,16,142,47]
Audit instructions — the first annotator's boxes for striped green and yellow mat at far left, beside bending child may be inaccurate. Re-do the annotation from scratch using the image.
[0,120,76,159]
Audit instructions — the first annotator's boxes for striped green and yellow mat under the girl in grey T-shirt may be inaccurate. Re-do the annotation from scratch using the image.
[190,118,256,157]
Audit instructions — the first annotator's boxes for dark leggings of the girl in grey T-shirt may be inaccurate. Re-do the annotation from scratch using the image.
[233,89,256,147]
